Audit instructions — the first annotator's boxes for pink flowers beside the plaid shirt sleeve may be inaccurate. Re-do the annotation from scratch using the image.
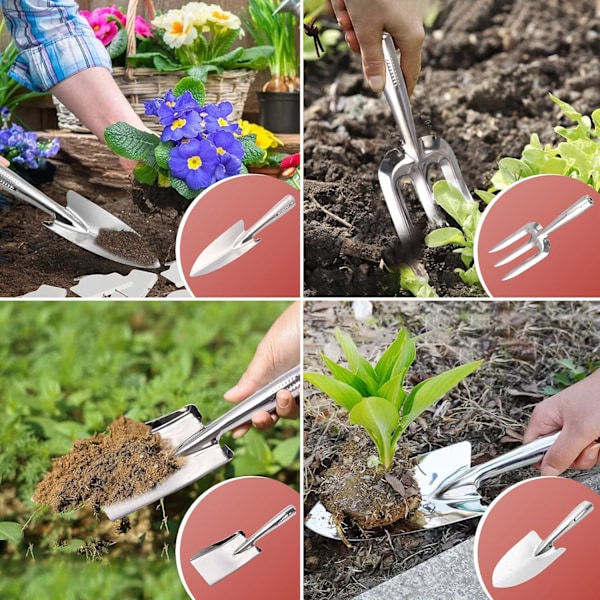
[79,4,152,55]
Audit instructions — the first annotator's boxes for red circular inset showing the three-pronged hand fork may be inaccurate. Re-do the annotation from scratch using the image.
[475,175,600,298]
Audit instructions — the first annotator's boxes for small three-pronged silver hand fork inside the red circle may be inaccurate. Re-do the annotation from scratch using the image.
[489,195,594,281]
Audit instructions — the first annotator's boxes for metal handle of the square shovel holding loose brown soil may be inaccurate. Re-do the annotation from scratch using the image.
[175,365,301,456]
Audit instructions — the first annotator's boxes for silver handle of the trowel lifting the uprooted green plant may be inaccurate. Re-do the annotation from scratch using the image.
[438,432,560,494]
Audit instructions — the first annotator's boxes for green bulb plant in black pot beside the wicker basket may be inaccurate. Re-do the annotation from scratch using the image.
[242,0,300,133]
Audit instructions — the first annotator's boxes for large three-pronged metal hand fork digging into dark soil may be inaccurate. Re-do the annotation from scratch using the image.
[379,33,473,242]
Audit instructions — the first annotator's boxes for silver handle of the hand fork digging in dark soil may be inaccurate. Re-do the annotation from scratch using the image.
[382,33,419,156]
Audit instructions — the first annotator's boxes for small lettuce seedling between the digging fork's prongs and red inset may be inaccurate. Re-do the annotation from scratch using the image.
[425,181,482,285]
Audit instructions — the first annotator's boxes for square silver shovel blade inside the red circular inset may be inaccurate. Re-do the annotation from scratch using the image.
[190,531,261,585]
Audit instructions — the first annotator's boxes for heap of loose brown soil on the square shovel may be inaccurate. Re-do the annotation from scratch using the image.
[33,417,184,512]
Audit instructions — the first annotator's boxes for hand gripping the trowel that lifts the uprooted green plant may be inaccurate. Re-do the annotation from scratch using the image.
[523,369,600,475]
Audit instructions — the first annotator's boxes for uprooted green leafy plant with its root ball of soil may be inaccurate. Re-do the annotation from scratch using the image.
[304,329,482,540]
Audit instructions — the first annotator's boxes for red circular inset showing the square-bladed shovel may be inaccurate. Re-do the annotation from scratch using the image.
[175,477,302,600]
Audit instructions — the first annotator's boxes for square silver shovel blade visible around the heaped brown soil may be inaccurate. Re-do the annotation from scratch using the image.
[102,404,233,521]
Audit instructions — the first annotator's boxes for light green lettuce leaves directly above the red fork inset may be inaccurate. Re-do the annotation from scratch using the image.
[476,94,600,197]
